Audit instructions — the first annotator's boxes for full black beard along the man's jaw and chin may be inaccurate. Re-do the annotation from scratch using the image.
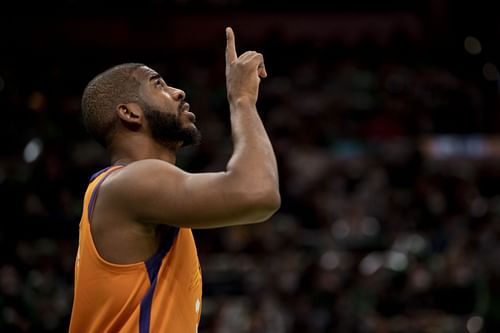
[143,106,201,147]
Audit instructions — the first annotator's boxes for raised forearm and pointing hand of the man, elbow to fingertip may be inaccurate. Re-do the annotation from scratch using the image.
[224,28,281,215]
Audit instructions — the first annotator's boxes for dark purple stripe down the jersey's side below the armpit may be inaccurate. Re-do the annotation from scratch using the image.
[139,228,179,333]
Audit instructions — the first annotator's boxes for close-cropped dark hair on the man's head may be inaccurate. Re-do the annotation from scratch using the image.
[82,63,145,146]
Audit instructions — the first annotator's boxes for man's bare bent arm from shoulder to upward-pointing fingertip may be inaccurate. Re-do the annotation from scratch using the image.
[100,28,280,228]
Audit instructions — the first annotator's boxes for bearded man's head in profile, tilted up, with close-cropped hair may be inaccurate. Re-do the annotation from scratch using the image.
[82,63,200,146]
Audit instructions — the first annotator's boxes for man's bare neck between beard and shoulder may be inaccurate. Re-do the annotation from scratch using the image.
[108,134,181,164]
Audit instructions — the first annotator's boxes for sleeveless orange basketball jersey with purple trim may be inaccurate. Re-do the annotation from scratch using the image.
[69,166,202,333]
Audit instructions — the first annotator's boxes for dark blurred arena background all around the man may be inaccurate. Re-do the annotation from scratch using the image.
[0,0,500,333]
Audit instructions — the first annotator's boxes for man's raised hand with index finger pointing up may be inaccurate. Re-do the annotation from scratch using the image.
[226,27,267,104]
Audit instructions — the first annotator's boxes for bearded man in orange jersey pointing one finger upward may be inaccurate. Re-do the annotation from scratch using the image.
[70,28,280,333]
